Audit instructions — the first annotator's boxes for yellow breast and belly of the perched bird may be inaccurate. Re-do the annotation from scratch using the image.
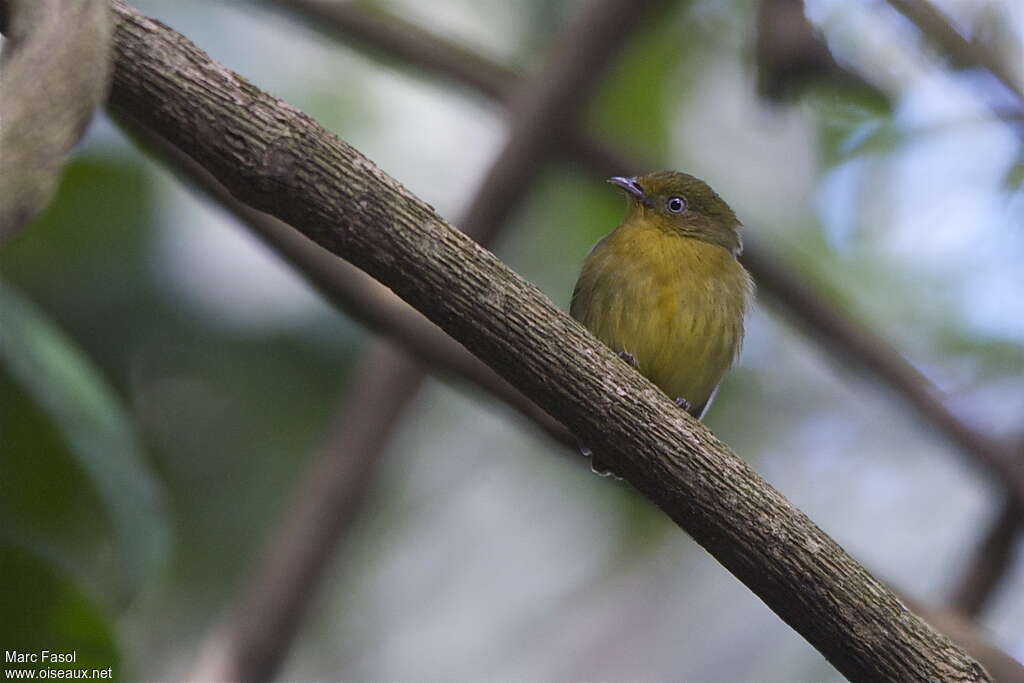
[570,223,753,415]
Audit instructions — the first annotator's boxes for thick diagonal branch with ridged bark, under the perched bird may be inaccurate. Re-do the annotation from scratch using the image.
[111,0,990,681]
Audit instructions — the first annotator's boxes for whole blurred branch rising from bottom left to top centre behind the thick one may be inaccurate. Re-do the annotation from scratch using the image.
[187,0,658,681]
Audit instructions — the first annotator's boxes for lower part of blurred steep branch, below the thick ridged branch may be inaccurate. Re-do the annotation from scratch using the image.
[189,342,424,683]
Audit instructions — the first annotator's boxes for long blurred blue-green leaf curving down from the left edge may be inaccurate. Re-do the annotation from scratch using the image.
[0,282,169,594]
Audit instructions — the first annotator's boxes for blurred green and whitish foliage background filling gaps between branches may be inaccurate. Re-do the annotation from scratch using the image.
[0,0,1024,680]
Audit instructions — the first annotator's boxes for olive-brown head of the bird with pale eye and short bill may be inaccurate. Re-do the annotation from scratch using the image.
[608,171,743,256]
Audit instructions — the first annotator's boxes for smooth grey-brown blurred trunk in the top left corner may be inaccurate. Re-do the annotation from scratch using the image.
[0,0,111,244]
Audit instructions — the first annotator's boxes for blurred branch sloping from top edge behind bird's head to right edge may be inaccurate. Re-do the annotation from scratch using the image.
[273,0,1024,505]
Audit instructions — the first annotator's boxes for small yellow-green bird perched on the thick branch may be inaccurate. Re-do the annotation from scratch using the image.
[569,171,754,473]
